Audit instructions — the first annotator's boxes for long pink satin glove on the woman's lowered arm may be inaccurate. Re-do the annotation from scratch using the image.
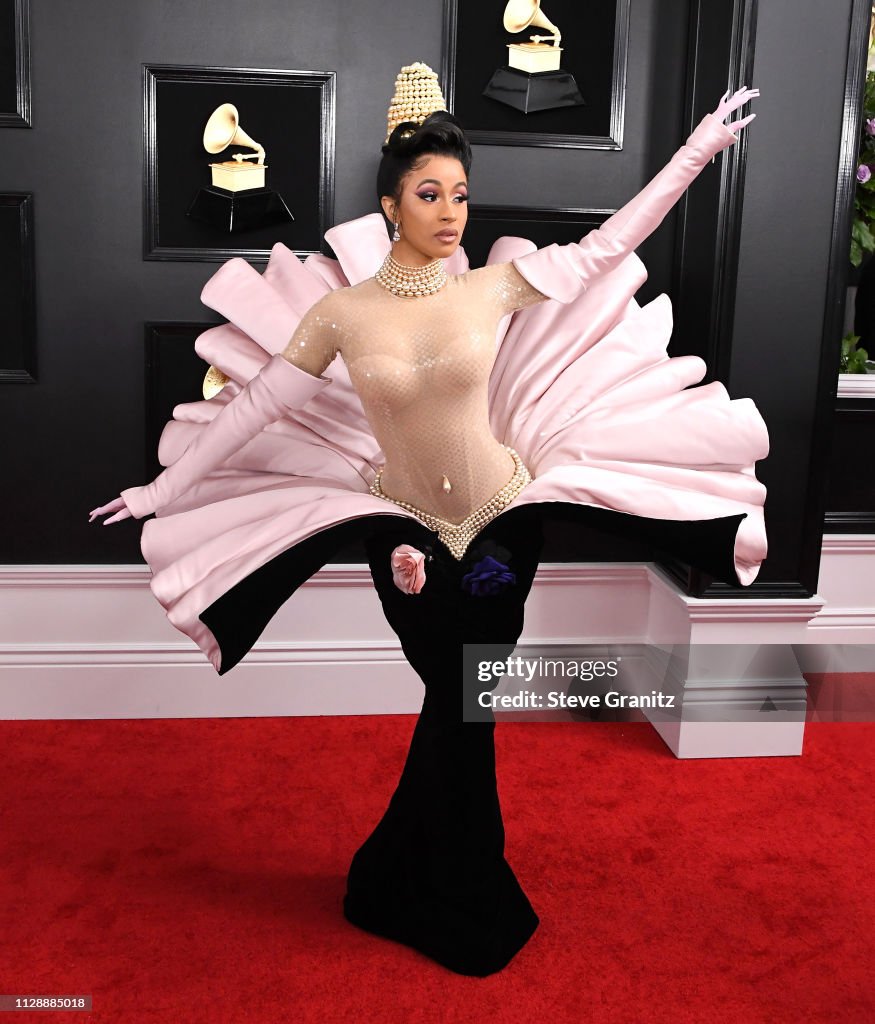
[88,353,331,526]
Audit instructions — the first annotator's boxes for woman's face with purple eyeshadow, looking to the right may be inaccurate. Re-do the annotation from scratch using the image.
[382,156,468,266]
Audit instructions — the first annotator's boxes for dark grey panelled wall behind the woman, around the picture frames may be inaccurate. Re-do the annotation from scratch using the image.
[0,0,864,602]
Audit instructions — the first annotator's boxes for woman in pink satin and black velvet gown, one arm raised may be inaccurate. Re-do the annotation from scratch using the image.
[90,65,767,976]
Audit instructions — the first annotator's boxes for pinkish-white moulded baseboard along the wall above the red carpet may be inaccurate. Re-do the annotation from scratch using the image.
[0,535,875,757]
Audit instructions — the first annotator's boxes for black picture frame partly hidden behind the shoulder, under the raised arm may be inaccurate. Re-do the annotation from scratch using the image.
[462,204,616,268]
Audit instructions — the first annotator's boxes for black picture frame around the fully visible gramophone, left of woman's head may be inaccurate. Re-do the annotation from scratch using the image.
[142,65,336,263]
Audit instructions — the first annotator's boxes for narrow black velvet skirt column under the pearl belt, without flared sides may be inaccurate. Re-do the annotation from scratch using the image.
[343,506,543,977]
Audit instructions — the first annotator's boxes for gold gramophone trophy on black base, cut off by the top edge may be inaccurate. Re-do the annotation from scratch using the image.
[483,0,585,114]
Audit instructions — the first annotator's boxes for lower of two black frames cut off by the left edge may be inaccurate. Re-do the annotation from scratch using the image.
[0,191,37,384]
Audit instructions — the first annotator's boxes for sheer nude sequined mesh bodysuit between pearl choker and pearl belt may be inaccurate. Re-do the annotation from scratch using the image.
[284,263,547,558]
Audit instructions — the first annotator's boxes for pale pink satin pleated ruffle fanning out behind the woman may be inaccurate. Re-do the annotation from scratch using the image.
[135,214,768,670]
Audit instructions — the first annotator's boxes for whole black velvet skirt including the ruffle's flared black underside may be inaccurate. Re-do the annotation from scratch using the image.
[200,491,744,976]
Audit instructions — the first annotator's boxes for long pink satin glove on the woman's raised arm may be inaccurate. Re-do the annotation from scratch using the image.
[511,88,759,302]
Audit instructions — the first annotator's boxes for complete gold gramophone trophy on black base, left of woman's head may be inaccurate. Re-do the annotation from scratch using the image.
[188,103,295,231]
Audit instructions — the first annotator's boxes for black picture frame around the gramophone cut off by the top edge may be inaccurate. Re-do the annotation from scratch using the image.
[442,0,630,150]
